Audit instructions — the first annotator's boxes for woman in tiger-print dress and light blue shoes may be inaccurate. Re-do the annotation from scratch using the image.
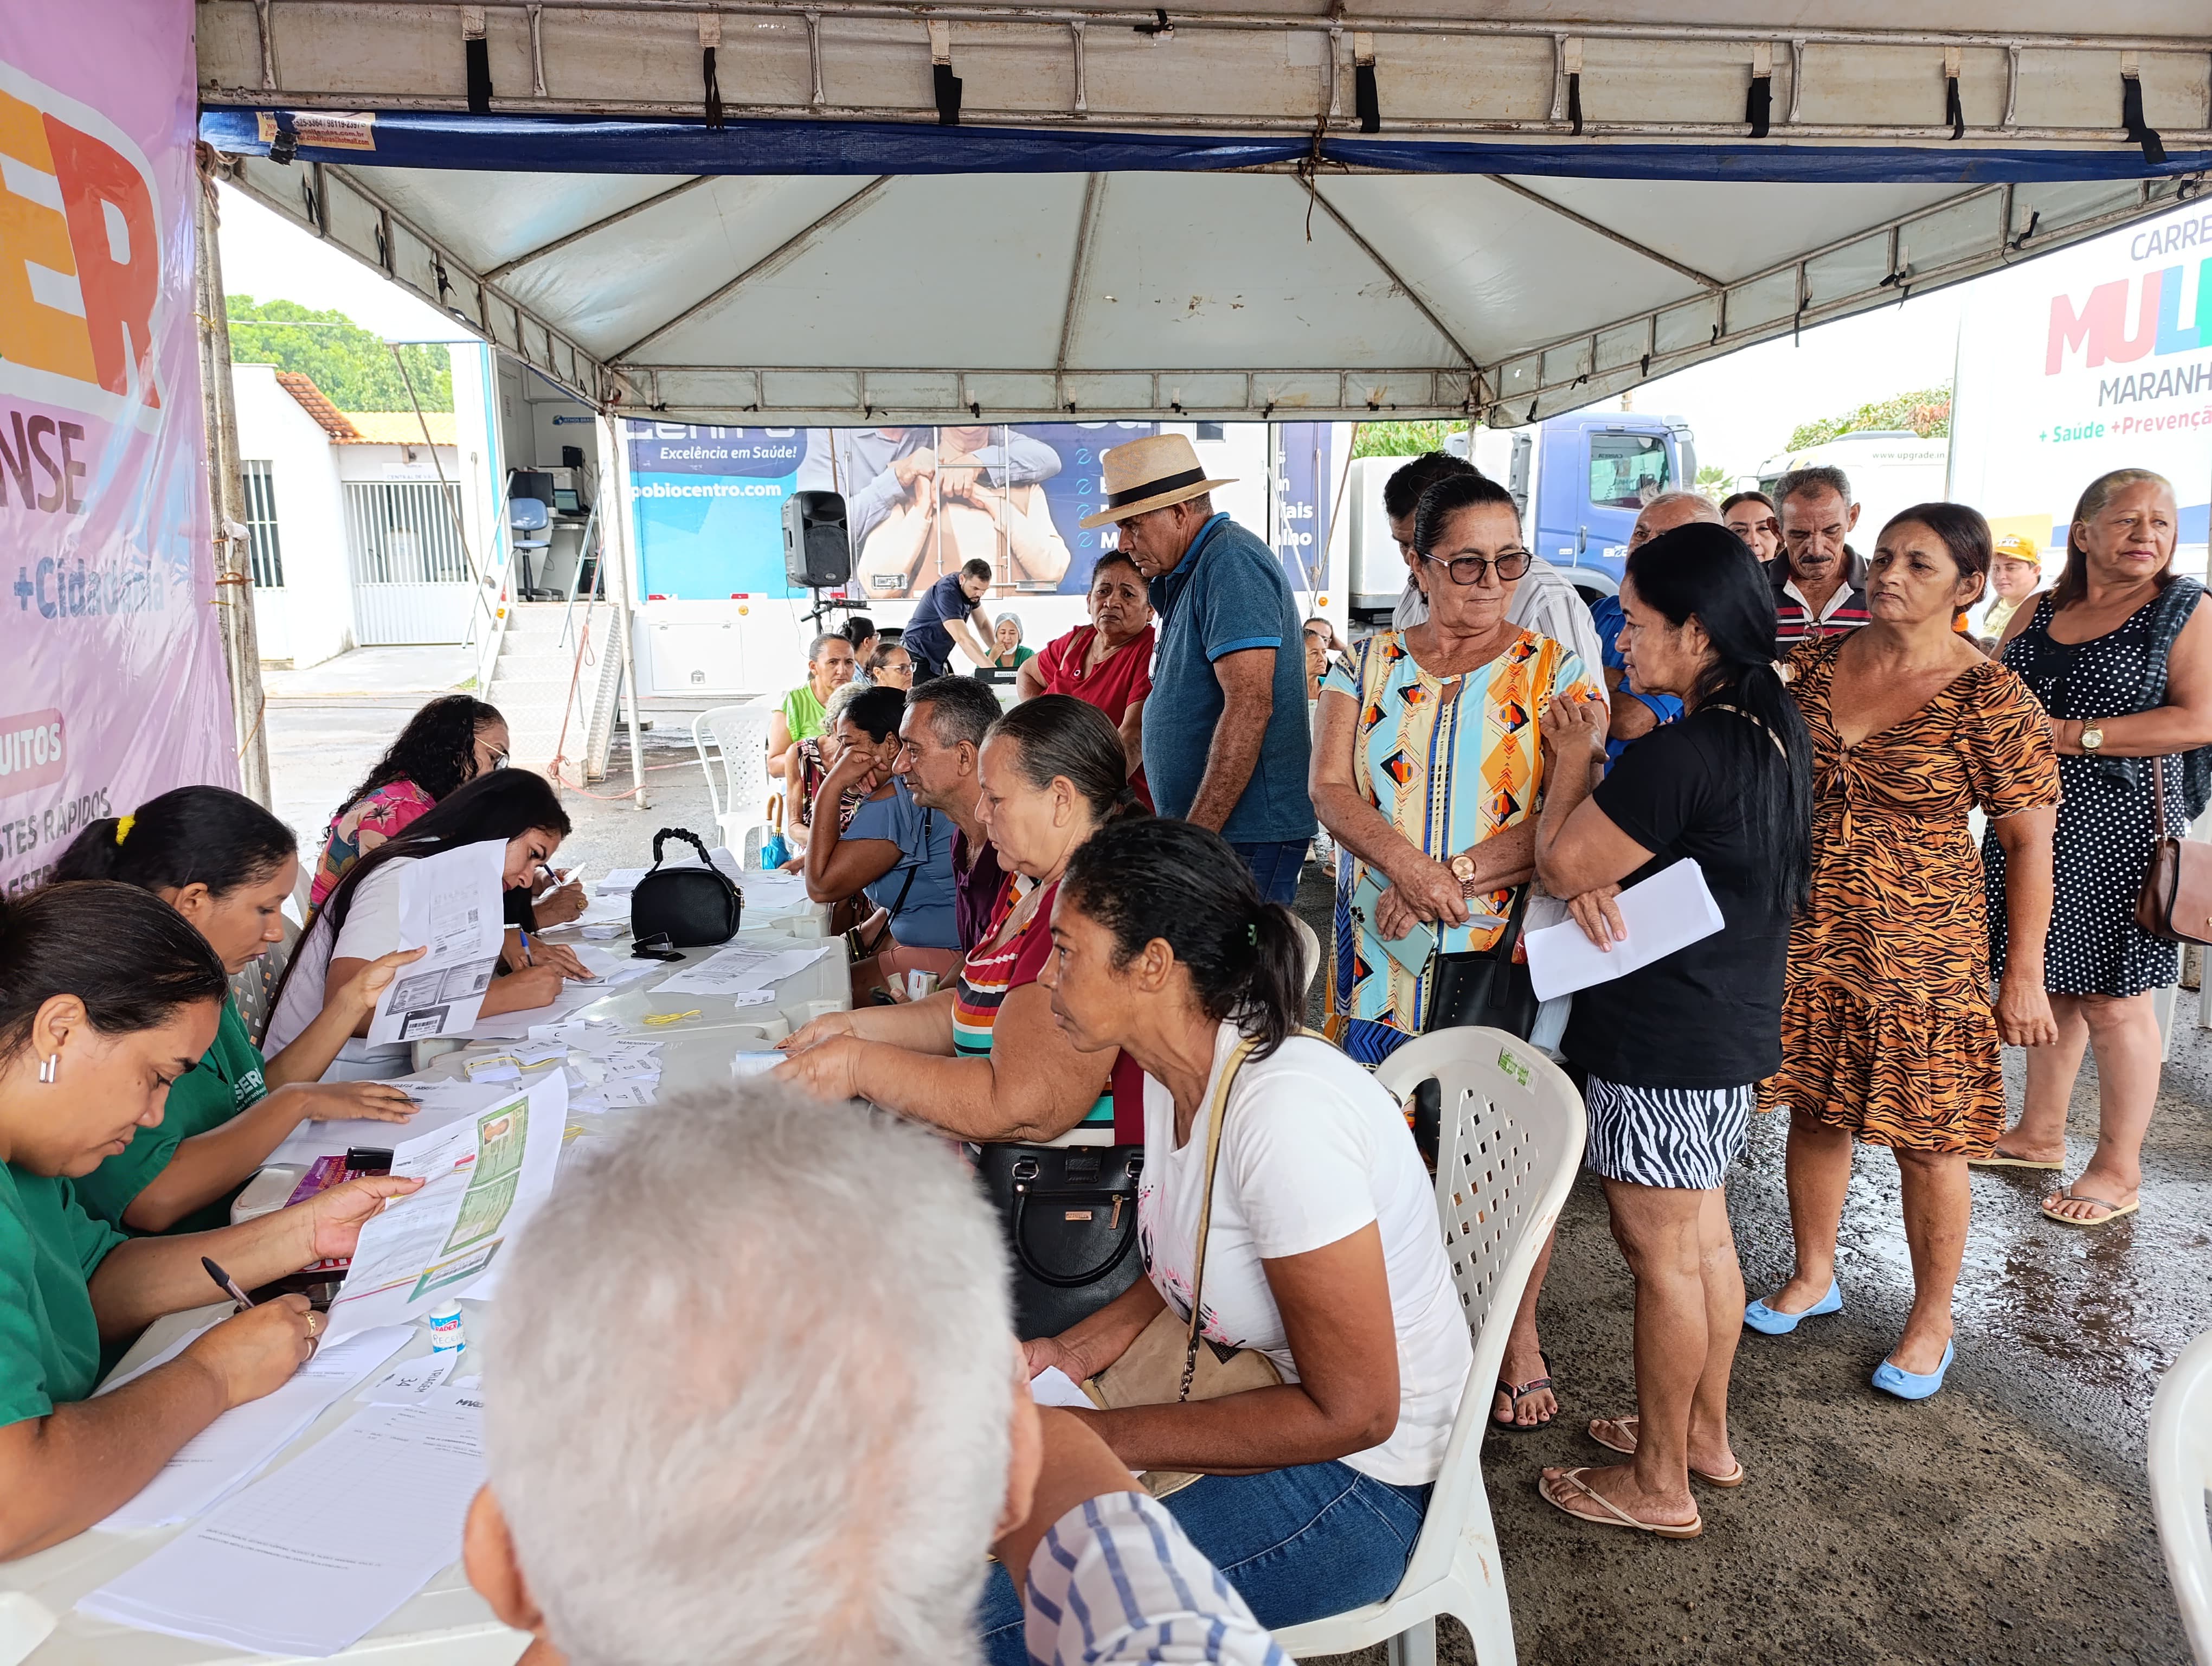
[1743,502,2059,1400]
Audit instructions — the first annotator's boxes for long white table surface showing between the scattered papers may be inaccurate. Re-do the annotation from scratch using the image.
[0,929,852,1666]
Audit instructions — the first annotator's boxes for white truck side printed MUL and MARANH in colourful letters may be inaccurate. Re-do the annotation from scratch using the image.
[1949,199,2212,582]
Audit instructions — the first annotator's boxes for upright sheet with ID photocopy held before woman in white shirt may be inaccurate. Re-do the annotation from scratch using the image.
[369,838,506,1047]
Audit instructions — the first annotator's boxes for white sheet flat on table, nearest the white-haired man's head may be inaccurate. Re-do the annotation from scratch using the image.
[78,1389,485,1659]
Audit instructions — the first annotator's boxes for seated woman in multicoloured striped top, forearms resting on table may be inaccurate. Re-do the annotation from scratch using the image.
[776,695,1141,1146]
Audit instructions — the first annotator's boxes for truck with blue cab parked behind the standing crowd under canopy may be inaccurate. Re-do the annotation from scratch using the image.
[1345,412,1696,624]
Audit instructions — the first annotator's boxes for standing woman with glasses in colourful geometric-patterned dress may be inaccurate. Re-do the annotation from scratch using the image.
[1311,476,1606,1429]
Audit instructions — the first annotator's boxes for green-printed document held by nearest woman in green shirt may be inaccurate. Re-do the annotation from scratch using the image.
[323,1071,569,1348]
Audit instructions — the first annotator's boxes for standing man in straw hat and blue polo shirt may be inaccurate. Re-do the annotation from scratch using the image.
[1082,434,1314,905]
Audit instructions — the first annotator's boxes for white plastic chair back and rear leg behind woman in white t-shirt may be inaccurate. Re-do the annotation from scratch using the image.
[1376,1029,1588,1591]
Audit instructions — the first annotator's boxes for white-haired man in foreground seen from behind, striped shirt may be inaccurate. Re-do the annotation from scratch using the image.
[467,1082,1283,1666]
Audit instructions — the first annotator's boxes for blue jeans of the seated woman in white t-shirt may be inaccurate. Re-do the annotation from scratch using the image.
[975,1463,1429,1666]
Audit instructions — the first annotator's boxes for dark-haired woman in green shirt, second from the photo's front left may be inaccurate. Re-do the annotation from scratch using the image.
[53,787,422,1232]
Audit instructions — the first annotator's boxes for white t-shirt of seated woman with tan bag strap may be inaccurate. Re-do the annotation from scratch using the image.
[1137,1024,1475,1487]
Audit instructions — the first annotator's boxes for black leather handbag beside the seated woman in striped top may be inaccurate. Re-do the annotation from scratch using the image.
[975,1146,1143,1341]
